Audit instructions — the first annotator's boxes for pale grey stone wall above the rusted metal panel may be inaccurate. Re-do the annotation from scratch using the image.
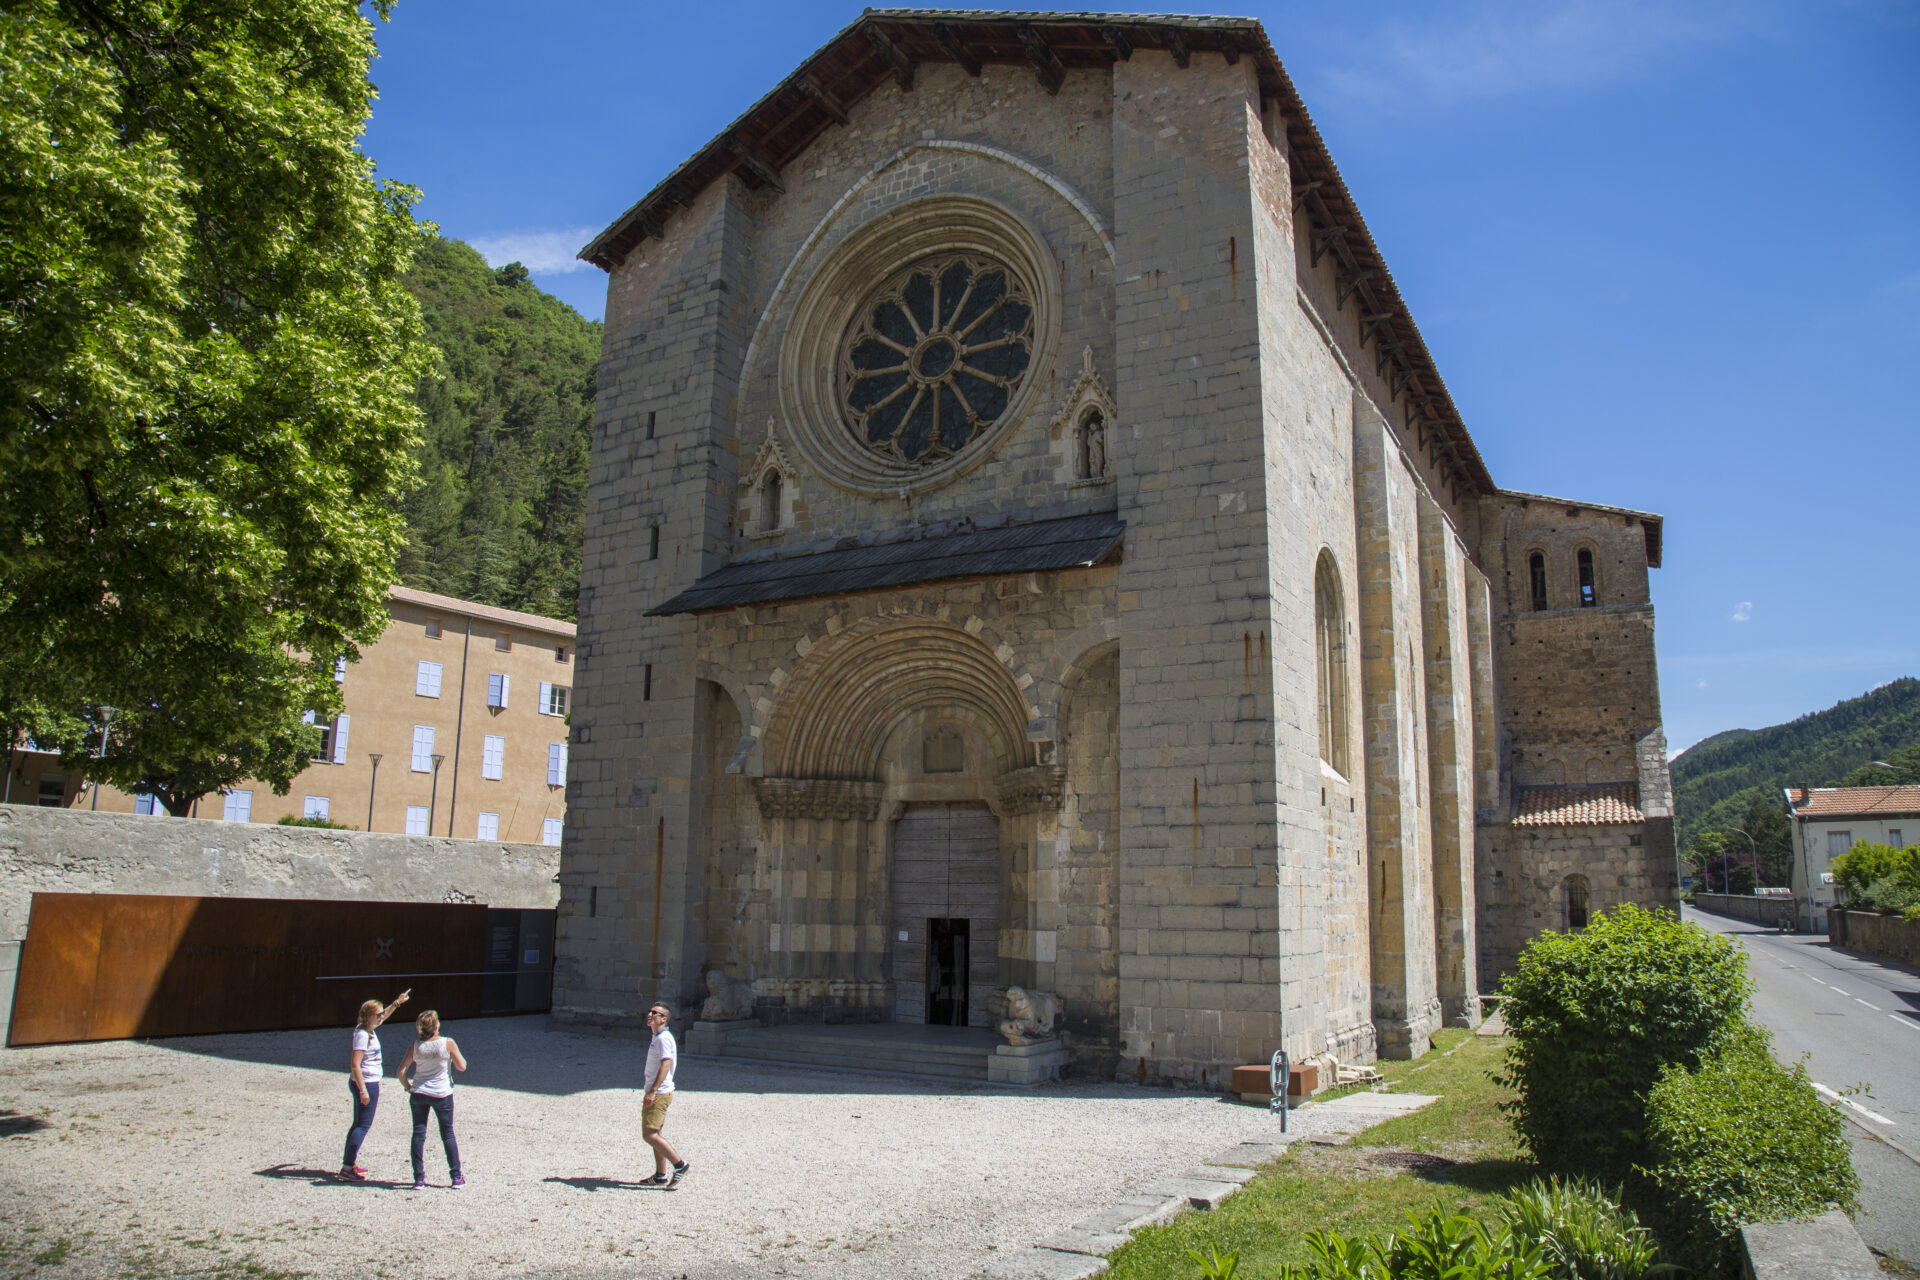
[0,804,561,942]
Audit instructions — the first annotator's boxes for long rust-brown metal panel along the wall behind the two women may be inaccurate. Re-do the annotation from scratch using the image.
[8,894,551,1046]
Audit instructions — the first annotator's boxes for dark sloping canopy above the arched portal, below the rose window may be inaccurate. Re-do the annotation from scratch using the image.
[647,514,1127,618]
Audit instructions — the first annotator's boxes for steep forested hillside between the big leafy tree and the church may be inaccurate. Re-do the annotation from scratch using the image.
[399,240,601,618]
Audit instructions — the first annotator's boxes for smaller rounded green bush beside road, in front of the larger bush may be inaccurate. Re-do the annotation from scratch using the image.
[1636,1027,1860,1276]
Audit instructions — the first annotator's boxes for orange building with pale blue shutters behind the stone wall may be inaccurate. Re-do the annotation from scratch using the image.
[78,587,574,844]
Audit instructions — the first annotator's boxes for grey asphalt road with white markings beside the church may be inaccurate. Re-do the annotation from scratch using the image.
[1686,908,1920,1265]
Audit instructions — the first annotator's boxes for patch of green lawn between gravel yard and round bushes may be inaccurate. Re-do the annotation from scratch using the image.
[1106,1031,1532,1280]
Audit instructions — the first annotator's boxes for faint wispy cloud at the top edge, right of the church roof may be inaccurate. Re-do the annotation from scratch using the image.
[1327,0,1770,102]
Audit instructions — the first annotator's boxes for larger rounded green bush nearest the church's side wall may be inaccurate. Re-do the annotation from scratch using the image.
[1496,904,1753,1182]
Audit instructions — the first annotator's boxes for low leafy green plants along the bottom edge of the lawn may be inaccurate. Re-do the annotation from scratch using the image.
[1274,1207,1553,1280]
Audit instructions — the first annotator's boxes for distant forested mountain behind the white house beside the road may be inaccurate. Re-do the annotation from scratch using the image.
[1672,677,1920,848]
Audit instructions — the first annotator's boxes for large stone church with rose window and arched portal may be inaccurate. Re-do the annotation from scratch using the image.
[555,12,1676,1084]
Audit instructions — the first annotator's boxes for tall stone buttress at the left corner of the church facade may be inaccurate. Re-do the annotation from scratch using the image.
[553,172,751,1027]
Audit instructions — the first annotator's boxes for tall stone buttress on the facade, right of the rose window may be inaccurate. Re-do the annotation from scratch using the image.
[1114,52,1281,1084]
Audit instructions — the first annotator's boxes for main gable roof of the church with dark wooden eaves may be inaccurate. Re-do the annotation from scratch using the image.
[580,10,1494,493]
